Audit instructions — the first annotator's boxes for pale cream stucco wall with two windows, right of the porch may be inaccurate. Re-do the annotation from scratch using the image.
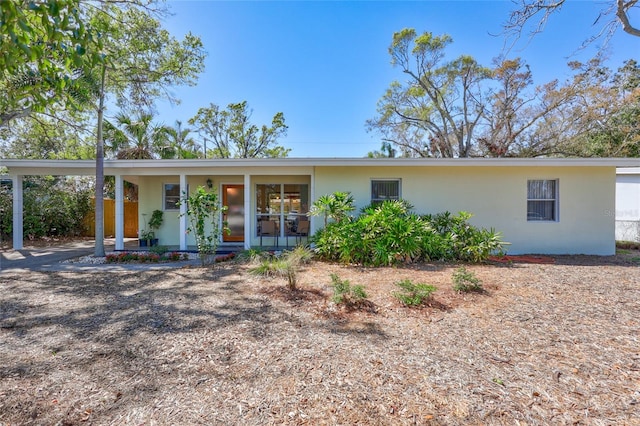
[315,167,615,255]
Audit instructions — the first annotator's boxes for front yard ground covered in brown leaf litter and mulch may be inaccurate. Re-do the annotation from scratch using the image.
[0,252,640,425]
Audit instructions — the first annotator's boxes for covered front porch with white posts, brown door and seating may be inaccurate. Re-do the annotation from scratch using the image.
[2,159,315,251]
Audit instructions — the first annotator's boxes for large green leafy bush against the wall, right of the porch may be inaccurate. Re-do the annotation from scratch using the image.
[312,200,503,266]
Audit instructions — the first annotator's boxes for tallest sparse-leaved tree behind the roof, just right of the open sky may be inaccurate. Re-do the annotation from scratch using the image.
[367,28,491,157]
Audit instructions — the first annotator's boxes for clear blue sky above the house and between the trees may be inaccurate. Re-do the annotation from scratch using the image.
[158,0,640,157]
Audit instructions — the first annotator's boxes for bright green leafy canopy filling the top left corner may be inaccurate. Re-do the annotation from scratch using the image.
[0,0,103,127]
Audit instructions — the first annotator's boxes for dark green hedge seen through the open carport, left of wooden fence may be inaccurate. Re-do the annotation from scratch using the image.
[0,177,92,239]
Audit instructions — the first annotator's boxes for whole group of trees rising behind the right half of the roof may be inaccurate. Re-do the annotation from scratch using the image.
[367,29,640,157]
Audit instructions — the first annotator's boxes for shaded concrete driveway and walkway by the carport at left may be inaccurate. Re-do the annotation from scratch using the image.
[0,239,200,275]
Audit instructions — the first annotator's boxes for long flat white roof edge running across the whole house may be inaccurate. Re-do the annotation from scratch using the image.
[0,158,640,176]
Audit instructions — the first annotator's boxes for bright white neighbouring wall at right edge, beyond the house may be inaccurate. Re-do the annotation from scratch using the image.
[616,167,640,242]
